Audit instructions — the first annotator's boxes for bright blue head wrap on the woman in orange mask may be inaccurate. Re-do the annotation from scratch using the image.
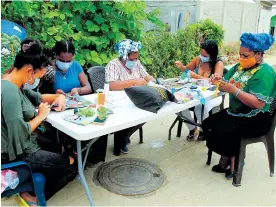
[240,33,274,52]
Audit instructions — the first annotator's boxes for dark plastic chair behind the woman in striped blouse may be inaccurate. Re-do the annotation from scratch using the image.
[87,66,144,144]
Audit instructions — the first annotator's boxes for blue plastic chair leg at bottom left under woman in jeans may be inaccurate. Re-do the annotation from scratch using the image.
[32,173,47,206]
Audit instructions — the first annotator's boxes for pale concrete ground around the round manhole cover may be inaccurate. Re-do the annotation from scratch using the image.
[2,58,276,206]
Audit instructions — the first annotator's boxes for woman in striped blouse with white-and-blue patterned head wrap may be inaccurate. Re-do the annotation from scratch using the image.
[105,39,153,156]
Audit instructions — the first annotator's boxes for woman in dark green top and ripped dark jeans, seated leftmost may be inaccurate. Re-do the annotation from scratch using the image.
[1,39,77,205]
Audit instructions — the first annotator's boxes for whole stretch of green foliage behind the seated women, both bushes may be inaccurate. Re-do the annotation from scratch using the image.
[1,1,224,78]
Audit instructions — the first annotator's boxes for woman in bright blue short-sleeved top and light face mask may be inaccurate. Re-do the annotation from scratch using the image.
[53,40,92,95]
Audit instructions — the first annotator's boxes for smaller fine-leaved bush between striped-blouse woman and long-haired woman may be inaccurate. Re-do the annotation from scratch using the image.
[141,19,224,78]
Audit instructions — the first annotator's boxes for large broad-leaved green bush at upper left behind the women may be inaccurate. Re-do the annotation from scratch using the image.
[1,1,165,67]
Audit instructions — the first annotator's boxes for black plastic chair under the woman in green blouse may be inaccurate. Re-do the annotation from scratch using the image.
[206,97,276,187]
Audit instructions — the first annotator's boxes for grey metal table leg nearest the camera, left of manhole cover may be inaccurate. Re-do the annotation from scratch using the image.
[77,140,94,206]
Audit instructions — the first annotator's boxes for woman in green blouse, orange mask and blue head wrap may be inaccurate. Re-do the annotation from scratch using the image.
[202,33,276,178]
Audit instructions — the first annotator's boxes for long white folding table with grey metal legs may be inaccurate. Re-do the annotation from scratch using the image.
[46,90,221,206]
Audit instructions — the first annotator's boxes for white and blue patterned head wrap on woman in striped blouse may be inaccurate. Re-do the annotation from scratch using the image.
[114,39,142,60]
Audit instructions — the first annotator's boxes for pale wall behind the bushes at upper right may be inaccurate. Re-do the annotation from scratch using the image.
[145,0,275,43]
